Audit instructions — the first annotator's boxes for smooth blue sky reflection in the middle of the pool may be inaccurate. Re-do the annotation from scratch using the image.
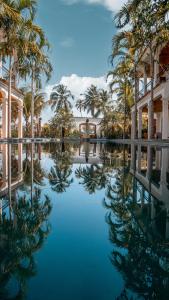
[28,160,123,300]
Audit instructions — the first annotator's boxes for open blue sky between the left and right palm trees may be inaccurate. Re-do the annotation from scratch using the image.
[37,0,124,120]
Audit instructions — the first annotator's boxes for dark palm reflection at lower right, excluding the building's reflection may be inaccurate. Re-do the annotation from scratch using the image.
[105,170,169,299]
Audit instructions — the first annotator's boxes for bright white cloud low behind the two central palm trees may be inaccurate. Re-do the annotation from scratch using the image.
[42,74,108,123]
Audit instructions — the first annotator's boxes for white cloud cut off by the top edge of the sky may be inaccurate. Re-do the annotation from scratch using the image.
[62,0,126,11]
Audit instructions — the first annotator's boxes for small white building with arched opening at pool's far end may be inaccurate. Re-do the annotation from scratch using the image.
[73,117,102,138]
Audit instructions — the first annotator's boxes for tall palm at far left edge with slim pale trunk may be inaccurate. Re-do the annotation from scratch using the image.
[1,0,36,138]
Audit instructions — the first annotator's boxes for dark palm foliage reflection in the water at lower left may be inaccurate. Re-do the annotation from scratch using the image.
[0,189,51,299]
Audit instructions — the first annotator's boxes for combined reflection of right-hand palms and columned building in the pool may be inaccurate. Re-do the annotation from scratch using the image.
[104,145,169,299]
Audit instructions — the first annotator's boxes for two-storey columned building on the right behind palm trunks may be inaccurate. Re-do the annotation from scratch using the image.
[132,43,169,139]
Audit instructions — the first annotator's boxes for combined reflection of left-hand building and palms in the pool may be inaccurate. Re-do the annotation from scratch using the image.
[0,144,51,300]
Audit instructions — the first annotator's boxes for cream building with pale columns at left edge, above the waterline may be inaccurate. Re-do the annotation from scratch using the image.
[0,62,23,138]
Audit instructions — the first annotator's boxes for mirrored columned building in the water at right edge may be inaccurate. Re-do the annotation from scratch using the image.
[131,145,169,238]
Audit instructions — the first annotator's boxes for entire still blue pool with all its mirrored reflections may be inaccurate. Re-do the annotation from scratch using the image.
[0,143,169,300]
